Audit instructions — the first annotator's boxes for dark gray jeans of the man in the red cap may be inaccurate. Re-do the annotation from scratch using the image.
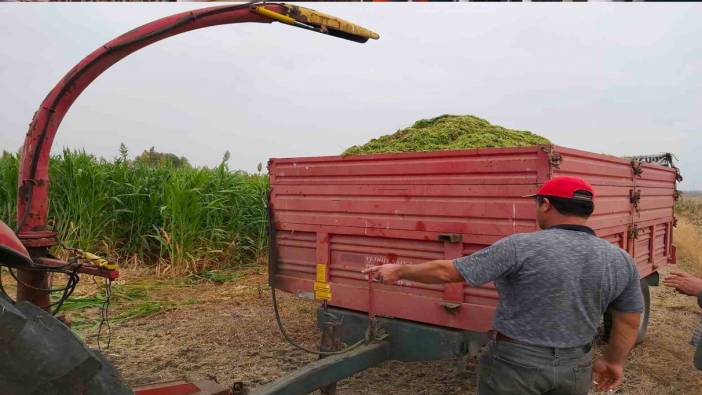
[478,340,592,395]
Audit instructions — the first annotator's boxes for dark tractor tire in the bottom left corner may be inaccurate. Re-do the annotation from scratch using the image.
[0,296,133,395]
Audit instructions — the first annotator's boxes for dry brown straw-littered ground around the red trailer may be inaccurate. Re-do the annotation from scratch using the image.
[66,262,702,395]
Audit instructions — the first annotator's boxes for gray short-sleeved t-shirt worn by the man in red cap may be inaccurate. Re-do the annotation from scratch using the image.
[453,225,644,347]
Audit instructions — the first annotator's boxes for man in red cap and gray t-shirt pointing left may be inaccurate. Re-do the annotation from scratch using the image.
[364,177,644,395]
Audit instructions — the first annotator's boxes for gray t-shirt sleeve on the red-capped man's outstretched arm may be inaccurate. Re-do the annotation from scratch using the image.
[453,237,518,287]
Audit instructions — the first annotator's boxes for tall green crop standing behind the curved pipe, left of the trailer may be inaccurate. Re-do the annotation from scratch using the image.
[0,150,268,273]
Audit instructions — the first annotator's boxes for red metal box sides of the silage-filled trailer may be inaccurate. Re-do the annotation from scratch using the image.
[269,146,675,331]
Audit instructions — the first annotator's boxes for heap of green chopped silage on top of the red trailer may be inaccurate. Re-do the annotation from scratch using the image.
[342,115,551,155]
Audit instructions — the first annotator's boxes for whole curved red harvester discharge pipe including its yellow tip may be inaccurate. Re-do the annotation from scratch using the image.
[16,3,378,308]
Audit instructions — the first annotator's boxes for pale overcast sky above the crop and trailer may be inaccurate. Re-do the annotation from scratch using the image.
[0,3,702,189]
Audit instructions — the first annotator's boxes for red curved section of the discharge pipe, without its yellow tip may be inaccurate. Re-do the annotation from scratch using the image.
[17,4,283,306]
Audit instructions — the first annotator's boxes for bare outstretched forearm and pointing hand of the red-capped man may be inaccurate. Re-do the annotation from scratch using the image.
[363,260,463,284]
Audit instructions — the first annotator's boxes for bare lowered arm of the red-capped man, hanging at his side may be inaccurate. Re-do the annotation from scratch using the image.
[592,310,641,391]
